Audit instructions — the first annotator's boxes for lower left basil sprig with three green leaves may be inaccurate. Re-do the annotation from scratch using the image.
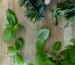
[8,38,24,65]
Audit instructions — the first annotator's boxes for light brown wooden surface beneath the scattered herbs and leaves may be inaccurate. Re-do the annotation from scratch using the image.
[0,0,75,65]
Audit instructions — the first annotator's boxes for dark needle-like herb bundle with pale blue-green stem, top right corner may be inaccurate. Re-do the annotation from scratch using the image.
[53,0,75,27]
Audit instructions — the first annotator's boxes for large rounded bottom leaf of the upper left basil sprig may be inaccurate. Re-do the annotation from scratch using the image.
[3,28,15,42]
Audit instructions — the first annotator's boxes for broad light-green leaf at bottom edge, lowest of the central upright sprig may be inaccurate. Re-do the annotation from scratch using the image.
[34,52,55,65]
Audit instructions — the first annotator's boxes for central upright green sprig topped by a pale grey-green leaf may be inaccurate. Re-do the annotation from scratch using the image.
[29,29,55,65]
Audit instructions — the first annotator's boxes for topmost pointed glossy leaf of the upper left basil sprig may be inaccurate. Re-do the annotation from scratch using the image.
[6,9,17,25]
